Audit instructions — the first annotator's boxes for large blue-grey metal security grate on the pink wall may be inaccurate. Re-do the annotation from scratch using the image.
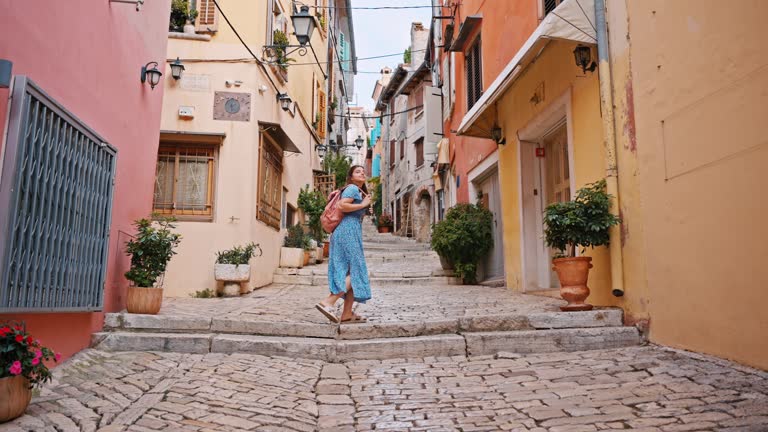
[0,76,117,312]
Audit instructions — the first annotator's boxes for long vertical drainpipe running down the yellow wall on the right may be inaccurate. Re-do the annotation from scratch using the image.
[595,0,624,297]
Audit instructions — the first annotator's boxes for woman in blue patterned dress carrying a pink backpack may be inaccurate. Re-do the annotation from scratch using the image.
[315,165,371,323]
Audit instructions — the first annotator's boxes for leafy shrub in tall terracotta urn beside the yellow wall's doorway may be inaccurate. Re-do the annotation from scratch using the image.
[544,180,621,311]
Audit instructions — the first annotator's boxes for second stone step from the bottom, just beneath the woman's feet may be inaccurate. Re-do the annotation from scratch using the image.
[104,309,622,340]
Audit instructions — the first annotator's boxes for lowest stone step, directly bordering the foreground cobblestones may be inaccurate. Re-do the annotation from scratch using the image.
[92,327,642,362]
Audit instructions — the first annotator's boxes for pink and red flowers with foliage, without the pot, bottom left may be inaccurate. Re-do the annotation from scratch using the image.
[0,323,61,386]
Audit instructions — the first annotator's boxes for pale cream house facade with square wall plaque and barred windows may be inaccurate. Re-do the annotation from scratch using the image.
[161,0,324,297]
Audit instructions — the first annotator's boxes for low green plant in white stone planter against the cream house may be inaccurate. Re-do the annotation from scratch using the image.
[213,242,262,297]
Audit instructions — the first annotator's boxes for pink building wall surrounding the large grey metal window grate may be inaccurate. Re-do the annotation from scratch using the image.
[0,0,171,357]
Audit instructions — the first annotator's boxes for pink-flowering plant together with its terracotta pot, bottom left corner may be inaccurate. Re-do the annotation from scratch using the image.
[0,322,61,423]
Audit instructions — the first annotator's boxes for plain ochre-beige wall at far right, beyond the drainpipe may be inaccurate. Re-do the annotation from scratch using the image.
[624,0,768,369]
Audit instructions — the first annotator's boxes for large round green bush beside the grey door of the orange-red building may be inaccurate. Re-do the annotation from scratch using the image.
[431,204,493,284]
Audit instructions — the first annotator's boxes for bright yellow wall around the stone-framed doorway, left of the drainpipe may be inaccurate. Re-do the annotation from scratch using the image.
[498,41,612,305]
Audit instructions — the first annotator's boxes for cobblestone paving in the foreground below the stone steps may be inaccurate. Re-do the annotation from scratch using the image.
[0,346,768,432]
